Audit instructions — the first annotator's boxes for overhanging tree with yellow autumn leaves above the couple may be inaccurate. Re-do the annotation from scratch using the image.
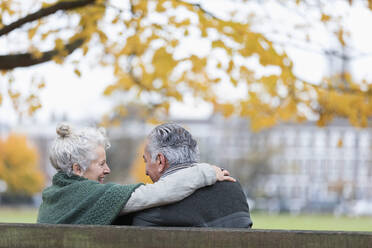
[0,0,372,130]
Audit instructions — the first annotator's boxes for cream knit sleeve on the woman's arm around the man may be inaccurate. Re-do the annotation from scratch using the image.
[120,164,217,215]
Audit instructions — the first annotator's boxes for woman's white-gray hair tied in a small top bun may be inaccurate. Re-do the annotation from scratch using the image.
[49,124,110,176]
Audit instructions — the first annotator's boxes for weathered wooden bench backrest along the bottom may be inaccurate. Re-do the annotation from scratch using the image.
[0,223,372,248]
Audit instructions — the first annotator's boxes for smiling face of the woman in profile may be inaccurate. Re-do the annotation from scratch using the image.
[83,146,111,183]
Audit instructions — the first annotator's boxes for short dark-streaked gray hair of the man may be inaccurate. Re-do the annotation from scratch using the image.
[147,123,199,166]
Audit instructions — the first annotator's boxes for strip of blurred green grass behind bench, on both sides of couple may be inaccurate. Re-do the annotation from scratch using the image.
[0,208,372,232]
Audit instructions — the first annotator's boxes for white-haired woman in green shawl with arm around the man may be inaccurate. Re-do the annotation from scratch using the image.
[37,125,234,225]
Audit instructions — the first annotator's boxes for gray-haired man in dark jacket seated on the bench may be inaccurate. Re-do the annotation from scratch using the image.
[133,123,252,228]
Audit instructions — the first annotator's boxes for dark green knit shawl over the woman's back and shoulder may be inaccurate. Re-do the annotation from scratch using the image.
[37,172,142,225]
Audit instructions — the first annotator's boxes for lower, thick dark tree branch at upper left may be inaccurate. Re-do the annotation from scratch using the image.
[0,39,84,70]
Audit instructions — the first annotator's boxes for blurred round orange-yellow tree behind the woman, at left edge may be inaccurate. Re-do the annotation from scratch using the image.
[0,134,45,195]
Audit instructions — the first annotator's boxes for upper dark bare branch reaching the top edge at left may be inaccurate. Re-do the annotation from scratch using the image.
[0,0,95,36]
